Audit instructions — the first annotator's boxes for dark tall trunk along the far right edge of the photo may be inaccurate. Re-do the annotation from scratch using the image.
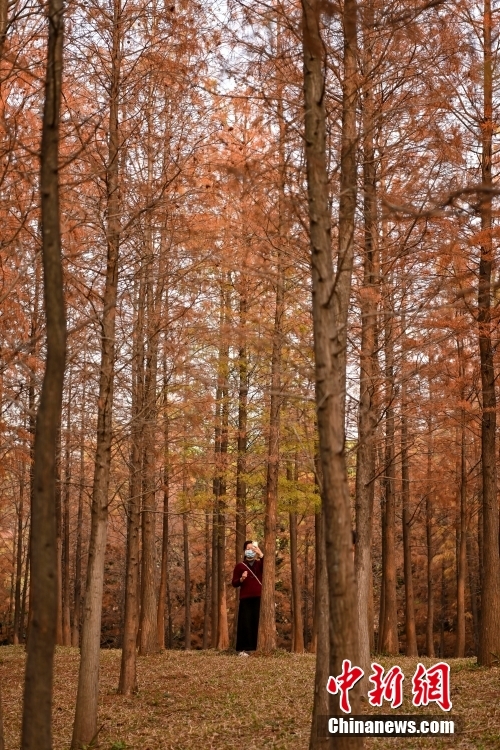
[477,0,500,667]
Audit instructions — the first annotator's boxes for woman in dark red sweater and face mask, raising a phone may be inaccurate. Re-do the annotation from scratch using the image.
[233,541,264,656]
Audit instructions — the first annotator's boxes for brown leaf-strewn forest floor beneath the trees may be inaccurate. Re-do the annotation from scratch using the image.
[0,646,500,750]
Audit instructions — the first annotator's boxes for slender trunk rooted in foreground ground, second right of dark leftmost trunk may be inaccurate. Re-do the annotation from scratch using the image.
[118,268,145,695]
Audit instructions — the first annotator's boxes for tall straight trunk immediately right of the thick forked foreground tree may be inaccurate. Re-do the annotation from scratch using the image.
[354,0,378,676]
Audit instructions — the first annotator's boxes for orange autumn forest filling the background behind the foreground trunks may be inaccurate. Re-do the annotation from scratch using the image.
[0,0,500,668]
